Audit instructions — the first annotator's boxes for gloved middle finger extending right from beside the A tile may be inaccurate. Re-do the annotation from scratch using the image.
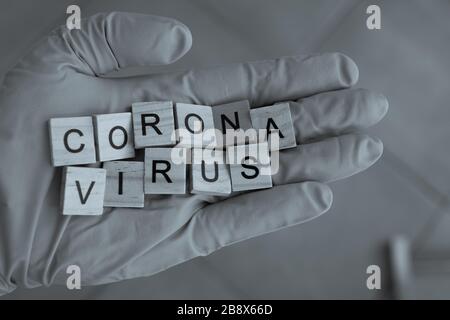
[290,89,389,143]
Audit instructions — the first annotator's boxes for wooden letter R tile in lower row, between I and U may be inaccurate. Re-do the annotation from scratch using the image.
[144,148,188,194]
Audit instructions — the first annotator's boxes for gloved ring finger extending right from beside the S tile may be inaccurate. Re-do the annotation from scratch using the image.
[272,134,383,185]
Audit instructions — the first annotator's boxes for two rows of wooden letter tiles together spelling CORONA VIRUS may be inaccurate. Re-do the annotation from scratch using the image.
[49,100,297,215]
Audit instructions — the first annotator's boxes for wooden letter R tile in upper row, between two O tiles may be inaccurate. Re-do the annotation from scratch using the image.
[131,101,176,149]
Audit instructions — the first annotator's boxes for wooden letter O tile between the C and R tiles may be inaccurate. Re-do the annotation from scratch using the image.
[94,112,135,161]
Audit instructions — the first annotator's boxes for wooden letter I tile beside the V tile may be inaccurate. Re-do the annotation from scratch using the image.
[103,161,144,208]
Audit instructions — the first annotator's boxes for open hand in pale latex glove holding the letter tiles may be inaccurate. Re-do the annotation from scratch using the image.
[0,13,388,294]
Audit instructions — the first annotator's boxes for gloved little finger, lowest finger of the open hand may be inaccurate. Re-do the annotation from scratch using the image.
[186,182,333,255]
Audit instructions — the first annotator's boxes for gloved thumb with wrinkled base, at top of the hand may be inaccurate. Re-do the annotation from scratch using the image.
[13,12,192,76]
